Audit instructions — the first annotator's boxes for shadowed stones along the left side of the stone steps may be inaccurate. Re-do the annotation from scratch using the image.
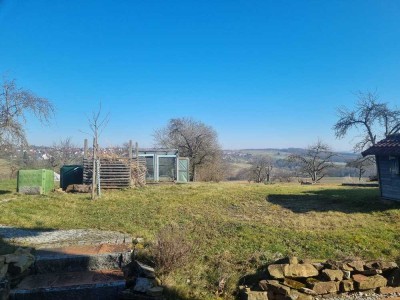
[0,248,35,300]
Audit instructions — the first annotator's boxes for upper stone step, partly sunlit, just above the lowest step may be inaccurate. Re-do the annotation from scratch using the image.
[34,244,131,274]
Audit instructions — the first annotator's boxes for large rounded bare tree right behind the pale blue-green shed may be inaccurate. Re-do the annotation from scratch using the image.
[154,118,221,181]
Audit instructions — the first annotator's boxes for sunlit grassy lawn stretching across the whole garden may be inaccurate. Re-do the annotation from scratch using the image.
[0,181,400,299]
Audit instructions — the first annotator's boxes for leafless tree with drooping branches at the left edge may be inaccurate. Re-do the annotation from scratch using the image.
[0,77,54,148]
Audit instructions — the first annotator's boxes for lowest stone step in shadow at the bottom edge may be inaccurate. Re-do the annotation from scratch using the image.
[10,270,125,300]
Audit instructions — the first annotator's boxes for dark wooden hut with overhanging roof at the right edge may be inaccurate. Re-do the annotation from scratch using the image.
[362,134,400,201]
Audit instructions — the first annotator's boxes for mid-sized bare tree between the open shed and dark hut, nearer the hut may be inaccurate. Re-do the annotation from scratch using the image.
[288,140,336,183]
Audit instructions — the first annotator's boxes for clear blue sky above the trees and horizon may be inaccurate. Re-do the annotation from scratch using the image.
[0,0,400,150]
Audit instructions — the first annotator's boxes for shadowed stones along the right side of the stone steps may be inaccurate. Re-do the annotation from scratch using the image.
[120,260,164,300]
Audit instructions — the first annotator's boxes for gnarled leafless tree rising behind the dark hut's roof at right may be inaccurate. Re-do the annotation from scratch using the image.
[333,92,400,151]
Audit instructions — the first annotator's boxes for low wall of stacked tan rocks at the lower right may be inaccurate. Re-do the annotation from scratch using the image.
[241,257,400,300]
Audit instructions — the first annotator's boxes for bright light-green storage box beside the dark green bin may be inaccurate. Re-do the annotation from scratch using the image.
[17,169,54,194]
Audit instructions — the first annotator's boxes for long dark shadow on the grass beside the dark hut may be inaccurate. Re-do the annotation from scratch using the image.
[266,188,400,214]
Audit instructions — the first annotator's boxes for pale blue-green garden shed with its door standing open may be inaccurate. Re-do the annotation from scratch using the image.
[138,148,189,182]
